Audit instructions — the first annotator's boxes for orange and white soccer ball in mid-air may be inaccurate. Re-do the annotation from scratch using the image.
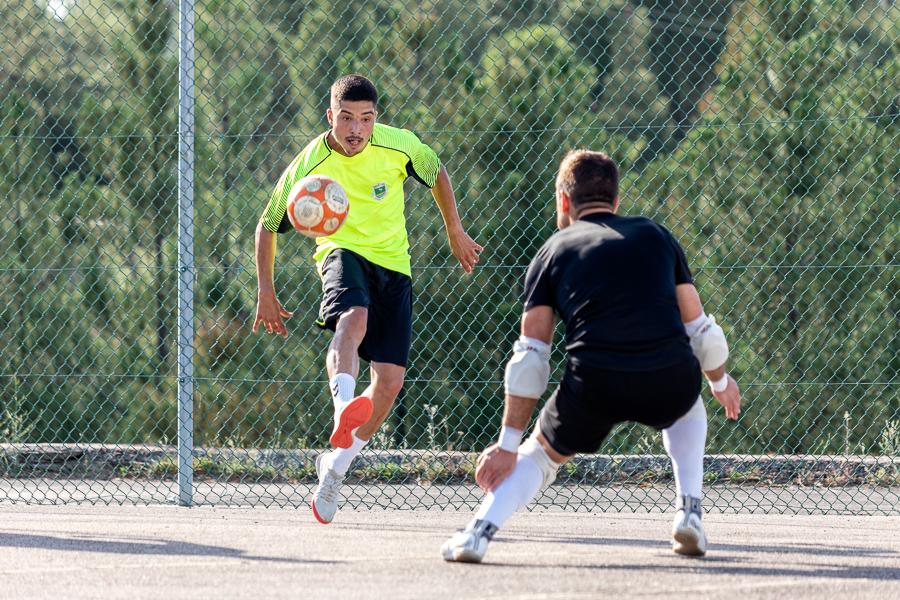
[287,175,350,238]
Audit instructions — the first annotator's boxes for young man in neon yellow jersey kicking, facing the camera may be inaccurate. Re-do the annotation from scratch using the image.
[253,75,483,523]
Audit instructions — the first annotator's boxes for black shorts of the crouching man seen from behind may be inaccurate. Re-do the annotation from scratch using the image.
[539,356,702,456]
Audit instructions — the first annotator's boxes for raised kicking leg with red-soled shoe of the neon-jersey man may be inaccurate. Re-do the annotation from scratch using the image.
[325,306,372,448]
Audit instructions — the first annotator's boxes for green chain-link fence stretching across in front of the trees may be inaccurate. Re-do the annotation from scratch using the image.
[0,0,900,513]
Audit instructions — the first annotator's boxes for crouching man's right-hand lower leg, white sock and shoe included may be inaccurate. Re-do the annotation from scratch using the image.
[663,398,706,556]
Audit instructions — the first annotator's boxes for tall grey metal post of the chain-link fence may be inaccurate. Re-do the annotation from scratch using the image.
[178,0,194,506]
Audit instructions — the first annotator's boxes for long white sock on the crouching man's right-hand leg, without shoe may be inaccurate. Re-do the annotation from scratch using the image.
[663,398,706,498]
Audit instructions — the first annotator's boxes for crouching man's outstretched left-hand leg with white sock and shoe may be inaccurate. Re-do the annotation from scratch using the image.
[441,428,572,562]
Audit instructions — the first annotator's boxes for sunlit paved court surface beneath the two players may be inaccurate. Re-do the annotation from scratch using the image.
[0,504,900,600]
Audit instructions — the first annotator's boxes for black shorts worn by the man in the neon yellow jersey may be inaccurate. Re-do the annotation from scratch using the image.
[316,248,412,367]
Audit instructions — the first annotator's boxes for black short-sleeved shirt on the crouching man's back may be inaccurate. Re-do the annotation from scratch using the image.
[525,213,693,371]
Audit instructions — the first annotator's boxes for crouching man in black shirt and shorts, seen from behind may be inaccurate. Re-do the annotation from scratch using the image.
[441,150,741,562]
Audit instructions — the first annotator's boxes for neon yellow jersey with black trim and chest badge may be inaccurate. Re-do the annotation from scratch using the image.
[260,123,441,275]
